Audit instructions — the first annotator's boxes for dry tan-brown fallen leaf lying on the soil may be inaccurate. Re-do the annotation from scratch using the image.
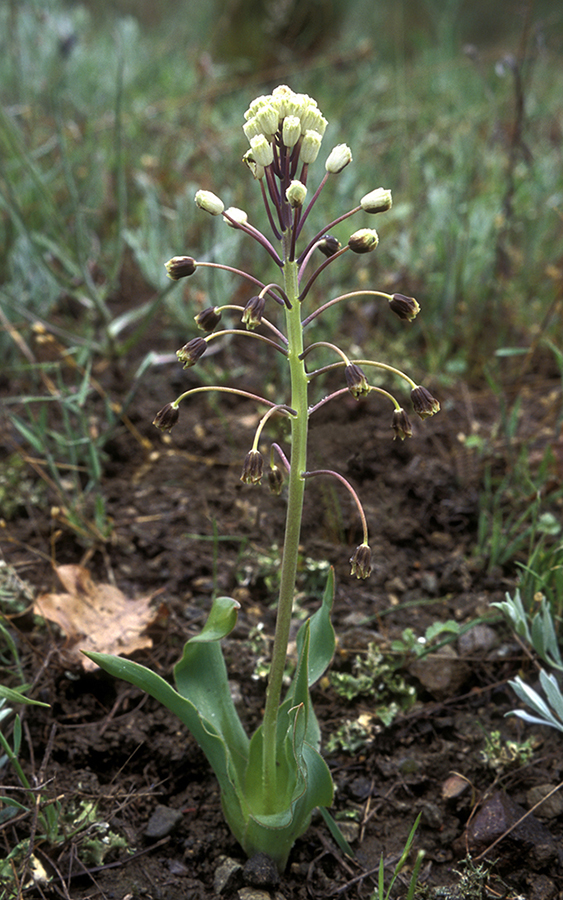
[34,565,158,671]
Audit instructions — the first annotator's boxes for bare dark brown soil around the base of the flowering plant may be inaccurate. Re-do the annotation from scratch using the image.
[0,312,563,900]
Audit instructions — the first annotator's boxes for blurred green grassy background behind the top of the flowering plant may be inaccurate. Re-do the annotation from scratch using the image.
[0,0,563,580]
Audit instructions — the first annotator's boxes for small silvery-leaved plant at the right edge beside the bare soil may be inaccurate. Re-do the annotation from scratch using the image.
[492,590,563,731]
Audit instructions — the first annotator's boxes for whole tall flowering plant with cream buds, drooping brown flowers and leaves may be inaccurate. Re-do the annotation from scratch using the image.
[88,85,440,870]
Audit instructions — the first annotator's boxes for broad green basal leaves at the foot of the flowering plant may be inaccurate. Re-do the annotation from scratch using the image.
[86,584,335,871]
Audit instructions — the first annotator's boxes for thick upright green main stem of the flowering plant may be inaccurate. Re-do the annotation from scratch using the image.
[263,231,308,805]
